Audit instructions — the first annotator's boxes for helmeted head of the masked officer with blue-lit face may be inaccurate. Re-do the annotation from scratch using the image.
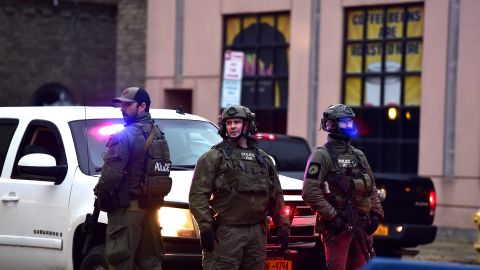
[320,104,358,138]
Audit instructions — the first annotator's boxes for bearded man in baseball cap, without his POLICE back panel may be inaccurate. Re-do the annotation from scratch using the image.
[94,87,164,270]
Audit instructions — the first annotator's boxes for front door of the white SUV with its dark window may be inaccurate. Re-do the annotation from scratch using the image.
[0,120,73,269]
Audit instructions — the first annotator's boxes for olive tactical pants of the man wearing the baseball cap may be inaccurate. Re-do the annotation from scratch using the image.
[105,201,165,270]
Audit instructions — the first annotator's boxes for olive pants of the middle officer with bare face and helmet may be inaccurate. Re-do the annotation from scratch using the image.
[202,224,267,270]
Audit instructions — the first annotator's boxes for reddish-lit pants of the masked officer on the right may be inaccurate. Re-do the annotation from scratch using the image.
[322,230,373,270]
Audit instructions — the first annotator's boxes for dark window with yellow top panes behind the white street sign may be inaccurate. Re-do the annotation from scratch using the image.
[224,12,290,133]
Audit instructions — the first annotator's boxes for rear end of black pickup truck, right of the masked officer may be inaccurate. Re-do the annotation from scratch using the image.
[374,173,437,256]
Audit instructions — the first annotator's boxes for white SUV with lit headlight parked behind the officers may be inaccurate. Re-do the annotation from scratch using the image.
[0,107,318,269]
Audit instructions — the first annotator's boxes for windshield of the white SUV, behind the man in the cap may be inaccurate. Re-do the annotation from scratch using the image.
[70,119,222,175]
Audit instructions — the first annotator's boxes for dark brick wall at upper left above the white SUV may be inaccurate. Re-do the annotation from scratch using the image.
[0,0,117,106]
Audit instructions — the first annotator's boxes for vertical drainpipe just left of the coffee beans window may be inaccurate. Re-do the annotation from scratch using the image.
[307,0,320,147]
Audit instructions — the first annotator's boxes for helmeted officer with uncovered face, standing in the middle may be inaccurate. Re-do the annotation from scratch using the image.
[189,105,290,270]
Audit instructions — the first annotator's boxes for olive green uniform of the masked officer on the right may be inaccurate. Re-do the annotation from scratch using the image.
[302,134,384,269]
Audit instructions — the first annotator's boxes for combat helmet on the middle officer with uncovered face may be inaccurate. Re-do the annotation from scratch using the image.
[218,105,258,138]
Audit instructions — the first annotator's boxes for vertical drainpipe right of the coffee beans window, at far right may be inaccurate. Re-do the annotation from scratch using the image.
[443,0,460,181]
